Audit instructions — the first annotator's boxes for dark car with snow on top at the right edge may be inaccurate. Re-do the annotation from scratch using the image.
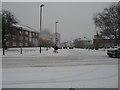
[107,47,120,58]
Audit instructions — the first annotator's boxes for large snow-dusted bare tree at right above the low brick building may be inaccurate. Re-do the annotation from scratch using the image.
[93,3,120,40]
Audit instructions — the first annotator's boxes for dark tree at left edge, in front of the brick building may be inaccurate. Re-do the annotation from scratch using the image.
[2,10,18,55]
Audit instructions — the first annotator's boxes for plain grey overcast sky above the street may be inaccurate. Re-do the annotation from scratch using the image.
[2,2,116,41]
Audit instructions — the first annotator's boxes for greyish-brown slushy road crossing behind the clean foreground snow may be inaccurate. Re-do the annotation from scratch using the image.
[2,49,118,68]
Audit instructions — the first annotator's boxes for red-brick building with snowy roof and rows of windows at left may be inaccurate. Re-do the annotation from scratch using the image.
[6,25,39,48]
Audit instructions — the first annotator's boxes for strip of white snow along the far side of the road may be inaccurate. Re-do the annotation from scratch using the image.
[0,47,116,57]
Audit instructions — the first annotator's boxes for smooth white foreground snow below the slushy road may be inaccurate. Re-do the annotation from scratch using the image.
[3,65,118,88]
